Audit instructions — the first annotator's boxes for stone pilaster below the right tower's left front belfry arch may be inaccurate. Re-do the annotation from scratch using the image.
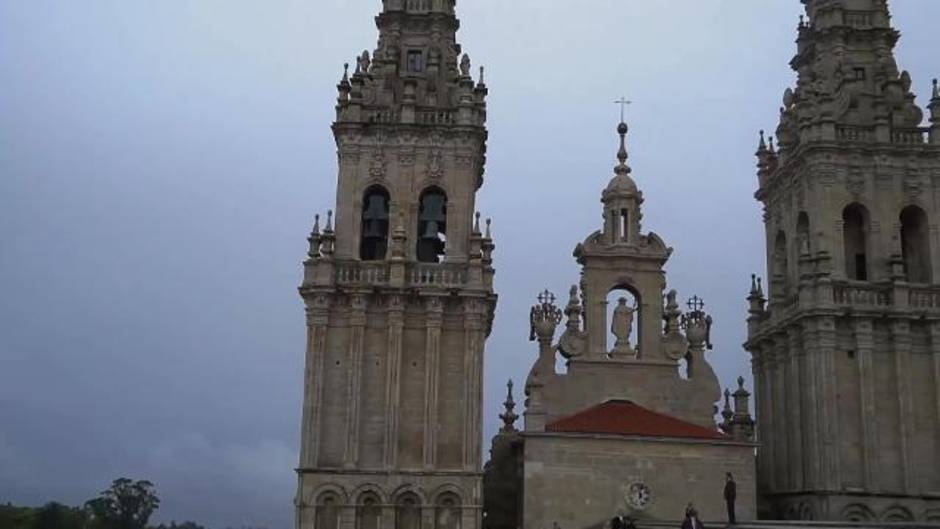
[853,319,880,490]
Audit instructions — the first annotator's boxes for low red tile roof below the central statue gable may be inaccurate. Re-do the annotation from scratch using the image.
[545,400,728,439]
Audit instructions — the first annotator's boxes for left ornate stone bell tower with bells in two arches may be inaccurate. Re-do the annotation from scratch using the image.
[296,0,496,529]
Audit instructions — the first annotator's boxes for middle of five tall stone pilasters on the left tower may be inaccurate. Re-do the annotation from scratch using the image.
[385,294,405,468]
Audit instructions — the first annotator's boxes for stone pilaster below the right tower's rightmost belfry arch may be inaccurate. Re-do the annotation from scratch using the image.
[891,320,919,494]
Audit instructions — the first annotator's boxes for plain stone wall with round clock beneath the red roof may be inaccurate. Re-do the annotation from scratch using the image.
[524,433,756,529]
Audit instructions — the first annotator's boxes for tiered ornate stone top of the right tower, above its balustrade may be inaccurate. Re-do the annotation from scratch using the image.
[777,0,923,156]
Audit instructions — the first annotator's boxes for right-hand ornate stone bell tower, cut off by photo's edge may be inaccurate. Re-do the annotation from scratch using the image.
[746,0,940,521]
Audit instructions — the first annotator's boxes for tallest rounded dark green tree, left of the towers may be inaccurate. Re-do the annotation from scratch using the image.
[85,478,160,529]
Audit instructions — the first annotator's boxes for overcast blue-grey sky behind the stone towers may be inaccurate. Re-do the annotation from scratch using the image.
[0,0,940,529]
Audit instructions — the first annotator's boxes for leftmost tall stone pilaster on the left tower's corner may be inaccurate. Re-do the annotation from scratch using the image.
[300,294,331,468]
